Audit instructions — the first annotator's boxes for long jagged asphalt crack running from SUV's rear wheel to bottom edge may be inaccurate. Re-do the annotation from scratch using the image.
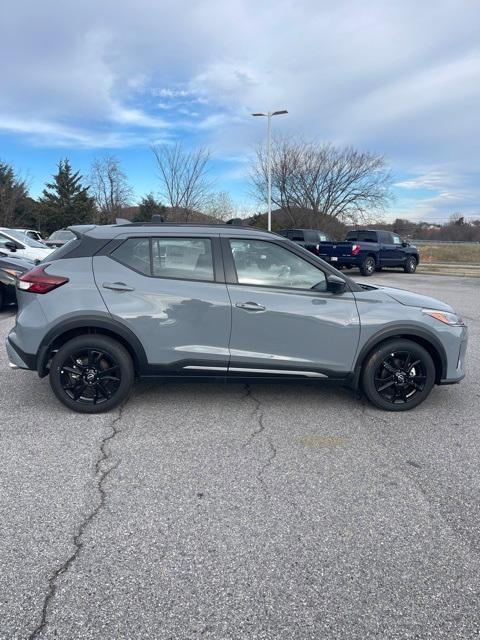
[28,407,123,640]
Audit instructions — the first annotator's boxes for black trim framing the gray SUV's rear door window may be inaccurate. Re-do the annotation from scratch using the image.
[106,233,225,284]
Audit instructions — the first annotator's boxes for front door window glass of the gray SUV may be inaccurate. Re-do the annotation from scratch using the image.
[230,240,327,291]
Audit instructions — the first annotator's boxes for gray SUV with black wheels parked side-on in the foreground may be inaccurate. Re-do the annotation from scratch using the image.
[7,223,467,413]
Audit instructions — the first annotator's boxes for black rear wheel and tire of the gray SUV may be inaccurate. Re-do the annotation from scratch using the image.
[50,334,134,413]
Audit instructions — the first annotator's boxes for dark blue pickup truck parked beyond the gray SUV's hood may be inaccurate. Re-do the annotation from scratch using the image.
[318,229,420,276]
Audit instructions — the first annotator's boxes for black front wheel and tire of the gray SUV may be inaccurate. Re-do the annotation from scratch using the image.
[361,338,435,411]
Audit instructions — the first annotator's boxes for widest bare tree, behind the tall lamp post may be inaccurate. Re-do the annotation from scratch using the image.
[250,140,391,222]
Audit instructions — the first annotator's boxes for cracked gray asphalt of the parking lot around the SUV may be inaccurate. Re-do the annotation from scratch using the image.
[0,273,480,640]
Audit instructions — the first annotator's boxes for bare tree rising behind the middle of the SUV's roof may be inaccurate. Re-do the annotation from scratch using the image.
[152,142,211,220]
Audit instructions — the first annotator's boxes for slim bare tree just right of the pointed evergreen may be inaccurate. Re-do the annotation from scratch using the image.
[90,156,133,224]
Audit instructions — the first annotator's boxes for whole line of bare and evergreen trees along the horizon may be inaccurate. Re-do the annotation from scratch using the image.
[0,139,476,239]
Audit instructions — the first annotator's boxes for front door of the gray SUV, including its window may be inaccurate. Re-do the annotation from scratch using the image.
[224,238,360,378]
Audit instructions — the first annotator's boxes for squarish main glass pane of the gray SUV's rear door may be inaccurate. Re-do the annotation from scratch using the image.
[152,237,214,281]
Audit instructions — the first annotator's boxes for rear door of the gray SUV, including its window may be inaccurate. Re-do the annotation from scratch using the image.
[93,234,231,374]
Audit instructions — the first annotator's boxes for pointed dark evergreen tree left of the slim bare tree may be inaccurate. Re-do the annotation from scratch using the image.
[39,158,95,232]
